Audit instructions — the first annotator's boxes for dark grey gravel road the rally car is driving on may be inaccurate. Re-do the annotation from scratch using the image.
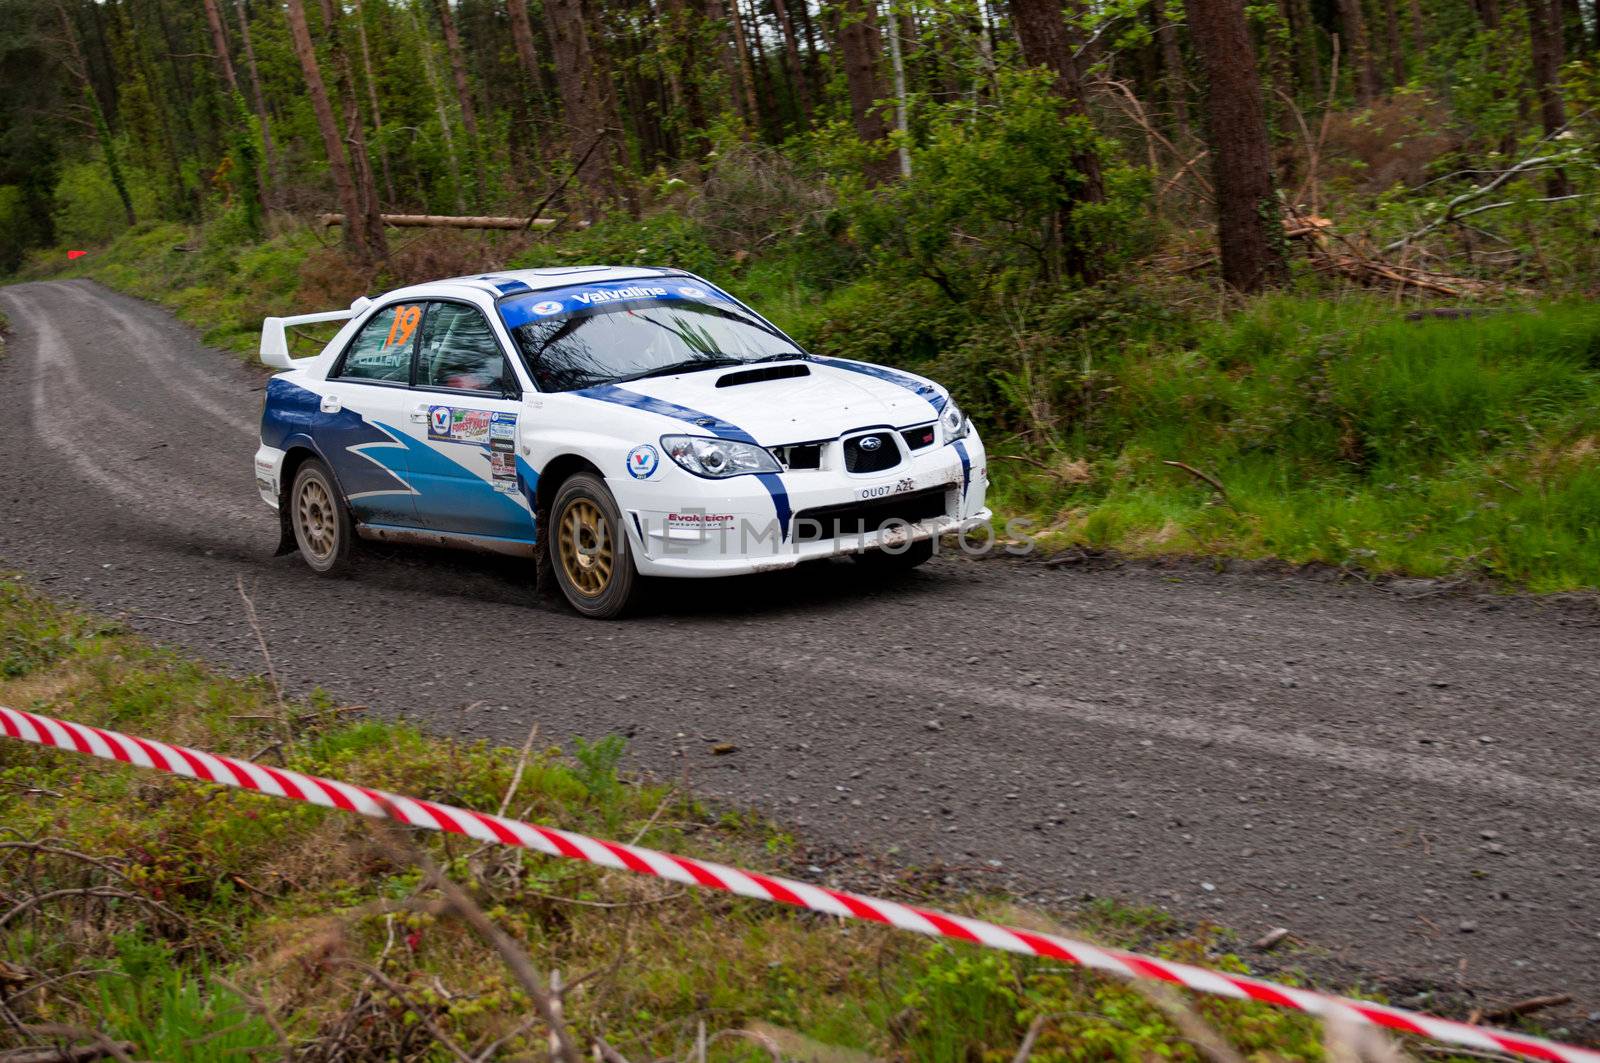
[0,280,1600,1021]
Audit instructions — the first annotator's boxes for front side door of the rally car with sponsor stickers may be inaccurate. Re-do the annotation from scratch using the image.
[406,299,533,541]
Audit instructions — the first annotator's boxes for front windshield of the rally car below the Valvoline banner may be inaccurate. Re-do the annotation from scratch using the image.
[507,299,805,391]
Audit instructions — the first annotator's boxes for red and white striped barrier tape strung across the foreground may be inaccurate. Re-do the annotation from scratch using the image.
[0,706,1600,1063]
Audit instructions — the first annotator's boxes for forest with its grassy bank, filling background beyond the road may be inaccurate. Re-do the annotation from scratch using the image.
[0,0,1600,589]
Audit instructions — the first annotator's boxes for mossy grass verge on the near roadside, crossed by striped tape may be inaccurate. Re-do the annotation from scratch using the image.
[0,578,1382,1063]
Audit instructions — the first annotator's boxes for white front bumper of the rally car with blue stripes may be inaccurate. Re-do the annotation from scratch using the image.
[608,432,990,576]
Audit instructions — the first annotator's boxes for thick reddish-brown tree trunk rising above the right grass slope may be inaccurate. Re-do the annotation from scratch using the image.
[1184,0,1285,291]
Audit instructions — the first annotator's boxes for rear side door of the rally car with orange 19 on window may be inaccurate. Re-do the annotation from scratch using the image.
[312,301,426,528]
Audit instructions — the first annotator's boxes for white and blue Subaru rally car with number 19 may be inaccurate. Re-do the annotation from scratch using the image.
[256,266,989,618]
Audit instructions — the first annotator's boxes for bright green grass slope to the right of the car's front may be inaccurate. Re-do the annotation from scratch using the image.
[994,298,1600,591]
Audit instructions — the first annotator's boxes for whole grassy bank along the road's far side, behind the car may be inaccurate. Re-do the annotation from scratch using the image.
[21,215,1600,592]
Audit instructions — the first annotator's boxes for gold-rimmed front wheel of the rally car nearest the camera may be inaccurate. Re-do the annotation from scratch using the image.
[546,472,638,620]
